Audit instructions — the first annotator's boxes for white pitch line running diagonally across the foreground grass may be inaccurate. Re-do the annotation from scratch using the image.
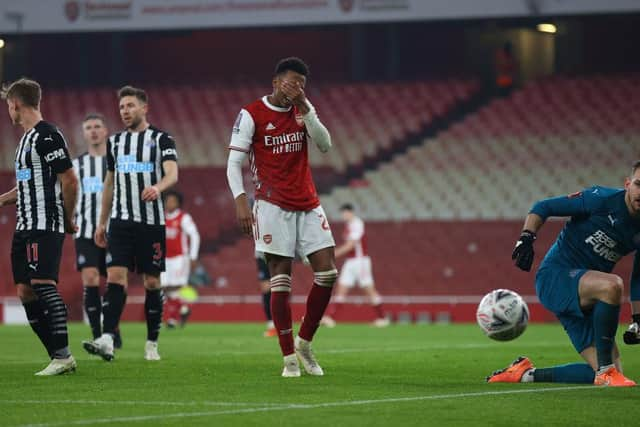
[18,385,597,427]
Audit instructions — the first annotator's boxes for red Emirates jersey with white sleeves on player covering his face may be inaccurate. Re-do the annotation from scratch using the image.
[229,96,320,211]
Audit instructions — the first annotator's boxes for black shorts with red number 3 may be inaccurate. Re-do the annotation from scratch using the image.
[106,219,166,277]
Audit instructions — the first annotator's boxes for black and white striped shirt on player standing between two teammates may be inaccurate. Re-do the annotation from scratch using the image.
[73,153,107,239]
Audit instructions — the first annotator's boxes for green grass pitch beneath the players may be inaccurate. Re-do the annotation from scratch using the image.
[0,324,640,427]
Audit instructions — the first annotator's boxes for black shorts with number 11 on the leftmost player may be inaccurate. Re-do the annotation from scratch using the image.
[11,230,64,285]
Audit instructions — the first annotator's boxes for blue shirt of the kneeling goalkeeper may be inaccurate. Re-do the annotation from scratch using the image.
[530,186,640,301]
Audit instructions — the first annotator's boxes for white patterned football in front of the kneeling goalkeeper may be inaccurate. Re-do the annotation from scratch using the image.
[476,289,529,341]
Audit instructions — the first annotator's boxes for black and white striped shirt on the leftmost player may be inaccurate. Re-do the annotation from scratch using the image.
[15,121,72,233]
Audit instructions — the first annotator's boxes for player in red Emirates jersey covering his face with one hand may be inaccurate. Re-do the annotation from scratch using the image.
[227,58,338,377]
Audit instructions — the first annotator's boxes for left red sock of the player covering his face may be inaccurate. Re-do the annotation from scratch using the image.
[270,274,294,356]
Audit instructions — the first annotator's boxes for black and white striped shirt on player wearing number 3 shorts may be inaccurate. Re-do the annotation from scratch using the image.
[107,126,177,225]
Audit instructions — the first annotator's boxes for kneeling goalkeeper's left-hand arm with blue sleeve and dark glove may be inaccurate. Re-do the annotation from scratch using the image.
[511,189,597,271]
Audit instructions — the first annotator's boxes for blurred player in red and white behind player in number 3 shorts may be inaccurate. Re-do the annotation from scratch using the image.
[160,190,200,328]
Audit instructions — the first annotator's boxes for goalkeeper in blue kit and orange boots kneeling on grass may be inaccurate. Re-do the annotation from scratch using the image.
[487,161,640,387]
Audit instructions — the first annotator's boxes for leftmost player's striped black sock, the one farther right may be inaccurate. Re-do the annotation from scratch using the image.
[31,284,71,359]
